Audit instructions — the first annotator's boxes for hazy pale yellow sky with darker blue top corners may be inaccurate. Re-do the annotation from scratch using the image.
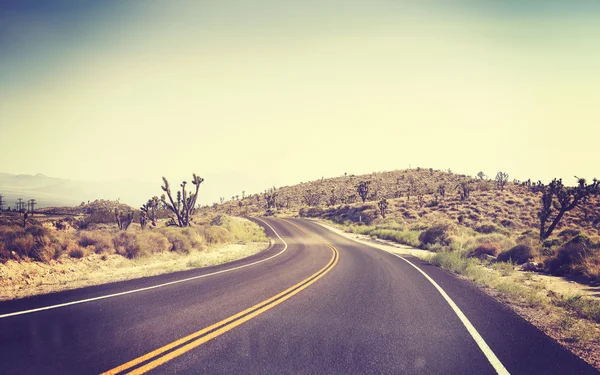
[0,0,600,201]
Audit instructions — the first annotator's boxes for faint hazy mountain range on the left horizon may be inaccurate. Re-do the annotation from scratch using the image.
[0,173,161,209]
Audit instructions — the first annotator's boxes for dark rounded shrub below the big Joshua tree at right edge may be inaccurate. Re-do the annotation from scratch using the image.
[544,234,594,276]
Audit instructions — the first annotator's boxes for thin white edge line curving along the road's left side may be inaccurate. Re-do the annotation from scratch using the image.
[0,218,288,319]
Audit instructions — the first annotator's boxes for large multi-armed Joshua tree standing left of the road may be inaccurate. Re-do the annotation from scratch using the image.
[160,173,204,227]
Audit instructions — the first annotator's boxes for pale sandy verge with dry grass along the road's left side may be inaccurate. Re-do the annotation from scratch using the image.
[0,242,269,301]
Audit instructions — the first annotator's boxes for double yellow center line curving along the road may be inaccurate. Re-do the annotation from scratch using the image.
[102,221,340,375]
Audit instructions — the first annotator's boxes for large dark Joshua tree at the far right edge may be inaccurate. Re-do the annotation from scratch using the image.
[532,177,600,241]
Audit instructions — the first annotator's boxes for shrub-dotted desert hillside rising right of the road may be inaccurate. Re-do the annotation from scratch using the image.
[210,168,600,281]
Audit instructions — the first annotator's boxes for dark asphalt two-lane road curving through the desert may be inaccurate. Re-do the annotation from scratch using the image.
[0,219,597,374]
